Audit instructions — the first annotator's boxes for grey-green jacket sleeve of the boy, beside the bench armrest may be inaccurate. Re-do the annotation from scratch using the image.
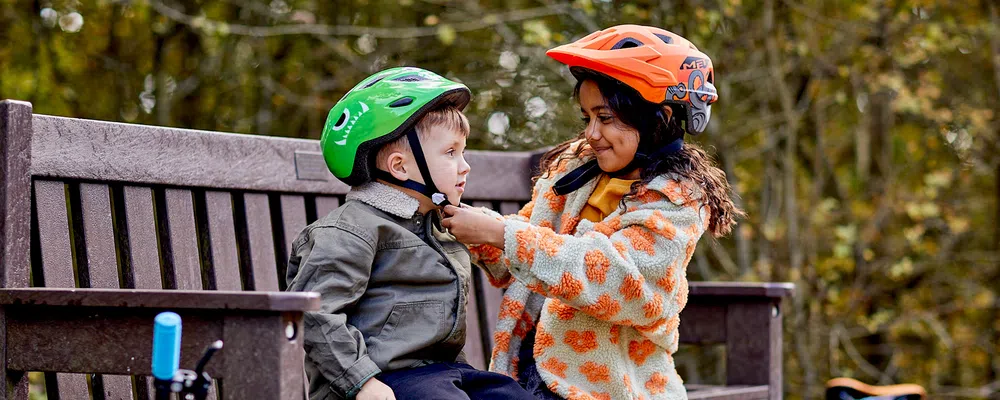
[289,223,381,398]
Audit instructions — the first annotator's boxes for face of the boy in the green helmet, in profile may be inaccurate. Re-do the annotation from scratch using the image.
[406,125,472,205]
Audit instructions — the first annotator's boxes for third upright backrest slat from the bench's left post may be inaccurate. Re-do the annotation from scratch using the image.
[125,186,163,289]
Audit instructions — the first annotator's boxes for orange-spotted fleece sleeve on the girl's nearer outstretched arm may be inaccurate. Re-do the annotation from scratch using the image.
[500,197,707,332]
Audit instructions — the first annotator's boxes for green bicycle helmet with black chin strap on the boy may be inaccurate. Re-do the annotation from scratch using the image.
[320,67,472,205]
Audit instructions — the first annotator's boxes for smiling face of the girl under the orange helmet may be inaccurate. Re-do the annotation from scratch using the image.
[579,80,639,179]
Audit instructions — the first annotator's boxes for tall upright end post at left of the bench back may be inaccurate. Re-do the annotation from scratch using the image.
[0,100,32,287]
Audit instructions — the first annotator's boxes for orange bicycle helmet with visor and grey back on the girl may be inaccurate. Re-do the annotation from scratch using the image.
[546,25,719,134]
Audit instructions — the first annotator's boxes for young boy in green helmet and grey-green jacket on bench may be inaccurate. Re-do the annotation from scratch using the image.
[286,68,531,400]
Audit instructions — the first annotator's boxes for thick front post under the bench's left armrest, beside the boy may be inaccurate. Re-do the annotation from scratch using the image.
[222,313,305,400]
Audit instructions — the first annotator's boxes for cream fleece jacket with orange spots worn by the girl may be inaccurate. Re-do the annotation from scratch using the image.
[471,142,709,399]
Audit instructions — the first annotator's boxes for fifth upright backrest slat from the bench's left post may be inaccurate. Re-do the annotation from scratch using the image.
[205,191,243,290]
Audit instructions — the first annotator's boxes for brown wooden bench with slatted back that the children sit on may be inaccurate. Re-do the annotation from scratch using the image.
[0,97,792,400]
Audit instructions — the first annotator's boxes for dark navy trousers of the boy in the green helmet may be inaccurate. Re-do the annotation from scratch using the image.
[375,363,534,400]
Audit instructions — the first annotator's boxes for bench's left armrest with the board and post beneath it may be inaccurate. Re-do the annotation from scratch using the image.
[0,288,319,400]
